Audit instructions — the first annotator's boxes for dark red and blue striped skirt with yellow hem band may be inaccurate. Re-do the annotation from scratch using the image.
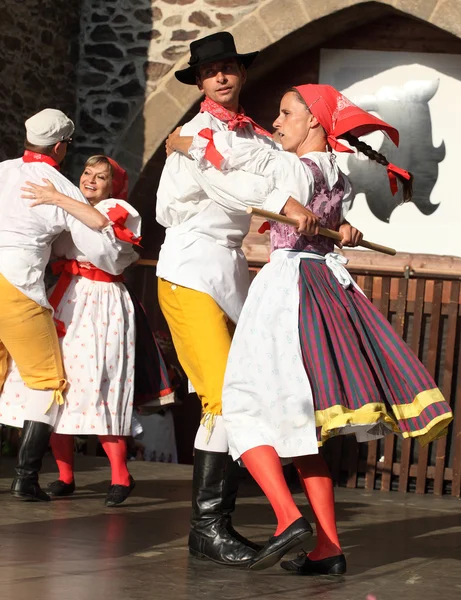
[299,258,453,445]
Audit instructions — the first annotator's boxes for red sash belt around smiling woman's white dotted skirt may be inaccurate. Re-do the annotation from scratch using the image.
[48,259,123,337]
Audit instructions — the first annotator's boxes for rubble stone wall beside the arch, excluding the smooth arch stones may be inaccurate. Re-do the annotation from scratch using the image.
[75,0,258,170]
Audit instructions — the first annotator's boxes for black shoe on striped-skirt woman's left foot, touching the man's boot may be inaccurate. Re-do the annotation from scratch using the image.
[249,517,312,571]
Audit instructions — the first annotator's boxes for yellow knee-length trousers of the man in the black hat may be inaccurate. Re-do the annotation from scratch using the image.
[158,279,234,415]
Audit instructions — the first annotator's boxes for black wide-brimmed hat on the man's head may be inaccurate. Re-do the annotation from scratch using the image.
[175,31,259,85]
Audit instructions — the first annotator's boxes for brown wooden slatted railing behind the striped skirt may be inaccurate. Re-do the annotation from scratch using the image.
[136,261,461,497]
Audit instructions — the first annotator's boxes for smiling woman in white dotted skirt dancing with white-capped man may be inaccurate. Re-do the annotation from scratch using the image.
[0,155,172,506]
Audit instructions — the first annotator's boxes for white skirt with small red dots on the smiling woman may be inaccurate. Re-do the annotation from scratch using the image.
[0,276,136,436]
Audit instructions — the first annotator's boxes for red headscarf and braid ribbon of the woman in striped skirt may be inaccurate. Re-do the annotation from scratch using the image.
[295,84,411,194]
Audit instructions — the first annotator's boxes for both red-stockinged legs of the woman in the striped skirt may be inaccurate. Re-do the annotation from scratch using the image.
[242,446,341,560]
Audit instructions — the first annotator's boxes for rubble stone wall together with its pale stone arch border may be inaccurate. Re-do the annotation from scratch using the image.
[71,0,461,185]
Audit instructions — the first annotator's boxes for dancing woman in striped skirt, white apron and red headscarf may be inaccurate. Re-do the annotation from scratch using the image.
[167,85,452,575]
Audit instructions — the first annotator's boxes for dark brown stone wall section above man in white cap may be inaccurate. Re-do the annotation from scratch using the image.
[0,0,81,160]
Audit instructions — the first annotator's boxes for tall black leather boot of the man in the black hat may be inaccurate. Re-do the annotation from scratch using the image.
[189,450,256,567]
